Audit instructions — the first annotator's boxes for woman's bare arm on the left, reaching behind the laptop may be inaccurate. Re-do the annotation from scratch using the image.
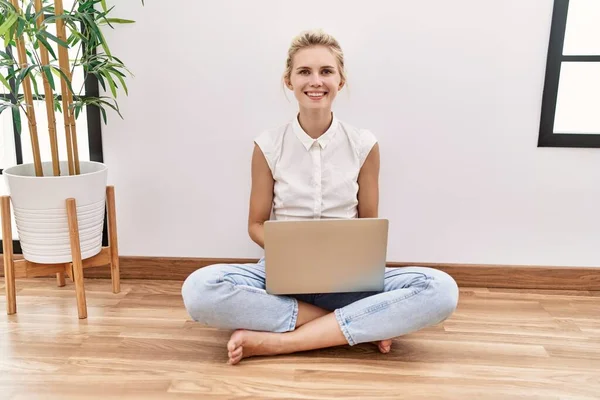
[248,144,274,248]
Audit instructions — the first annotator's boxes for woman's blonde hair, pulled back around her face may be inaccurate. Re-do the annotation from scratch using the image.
[283,29,346,86]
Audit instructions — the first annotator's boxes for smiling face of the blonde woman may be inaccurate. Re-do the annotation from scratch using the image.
[288,46,343,110]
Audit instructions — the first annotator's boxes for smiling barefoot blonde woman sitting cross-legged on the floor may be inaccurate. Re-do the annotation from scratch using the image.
[182,31,458,364]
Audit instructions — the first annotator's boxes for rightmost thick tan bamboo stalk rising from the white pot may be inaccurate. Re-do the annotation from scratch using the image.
[54,0,79,175]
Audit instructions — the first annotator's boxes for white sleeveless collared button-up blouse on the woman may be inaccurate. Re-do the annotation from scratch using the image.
[255,115,377,220]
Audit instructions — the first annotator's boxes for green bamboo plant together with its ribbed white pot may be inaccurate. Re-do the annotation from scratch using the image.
[0,0,133,264]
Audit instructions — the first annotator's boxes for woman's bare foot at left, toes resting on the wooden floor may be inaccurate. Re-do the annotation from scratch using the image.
[227,329,282,365]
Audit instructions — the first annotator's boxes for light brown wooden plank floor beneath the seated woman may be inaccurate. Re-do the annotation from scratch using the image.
[0,278,600,400]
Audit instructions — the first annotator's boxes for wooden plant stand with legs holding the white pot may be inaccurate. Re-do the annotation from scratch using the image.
[1,186,121,319]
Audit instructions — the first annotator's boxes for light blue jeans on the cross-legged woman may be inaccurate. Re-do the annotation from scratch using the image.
[181,259,458,346]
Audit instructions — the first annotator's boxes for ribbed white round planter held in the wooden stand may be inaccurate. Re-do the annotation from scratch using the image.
[2,161,108,264]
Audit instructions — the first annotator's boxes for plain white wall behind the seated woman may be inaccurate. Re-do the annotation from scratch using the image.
[103,0,600,266]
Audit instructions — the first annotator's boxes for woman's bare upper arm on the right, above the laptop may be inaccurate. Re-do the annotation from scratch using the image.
[358,143,379,218]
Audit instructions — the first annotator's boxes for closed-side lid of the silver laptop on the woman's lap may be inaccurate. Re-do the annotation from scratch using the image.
[264,218,389,295]
